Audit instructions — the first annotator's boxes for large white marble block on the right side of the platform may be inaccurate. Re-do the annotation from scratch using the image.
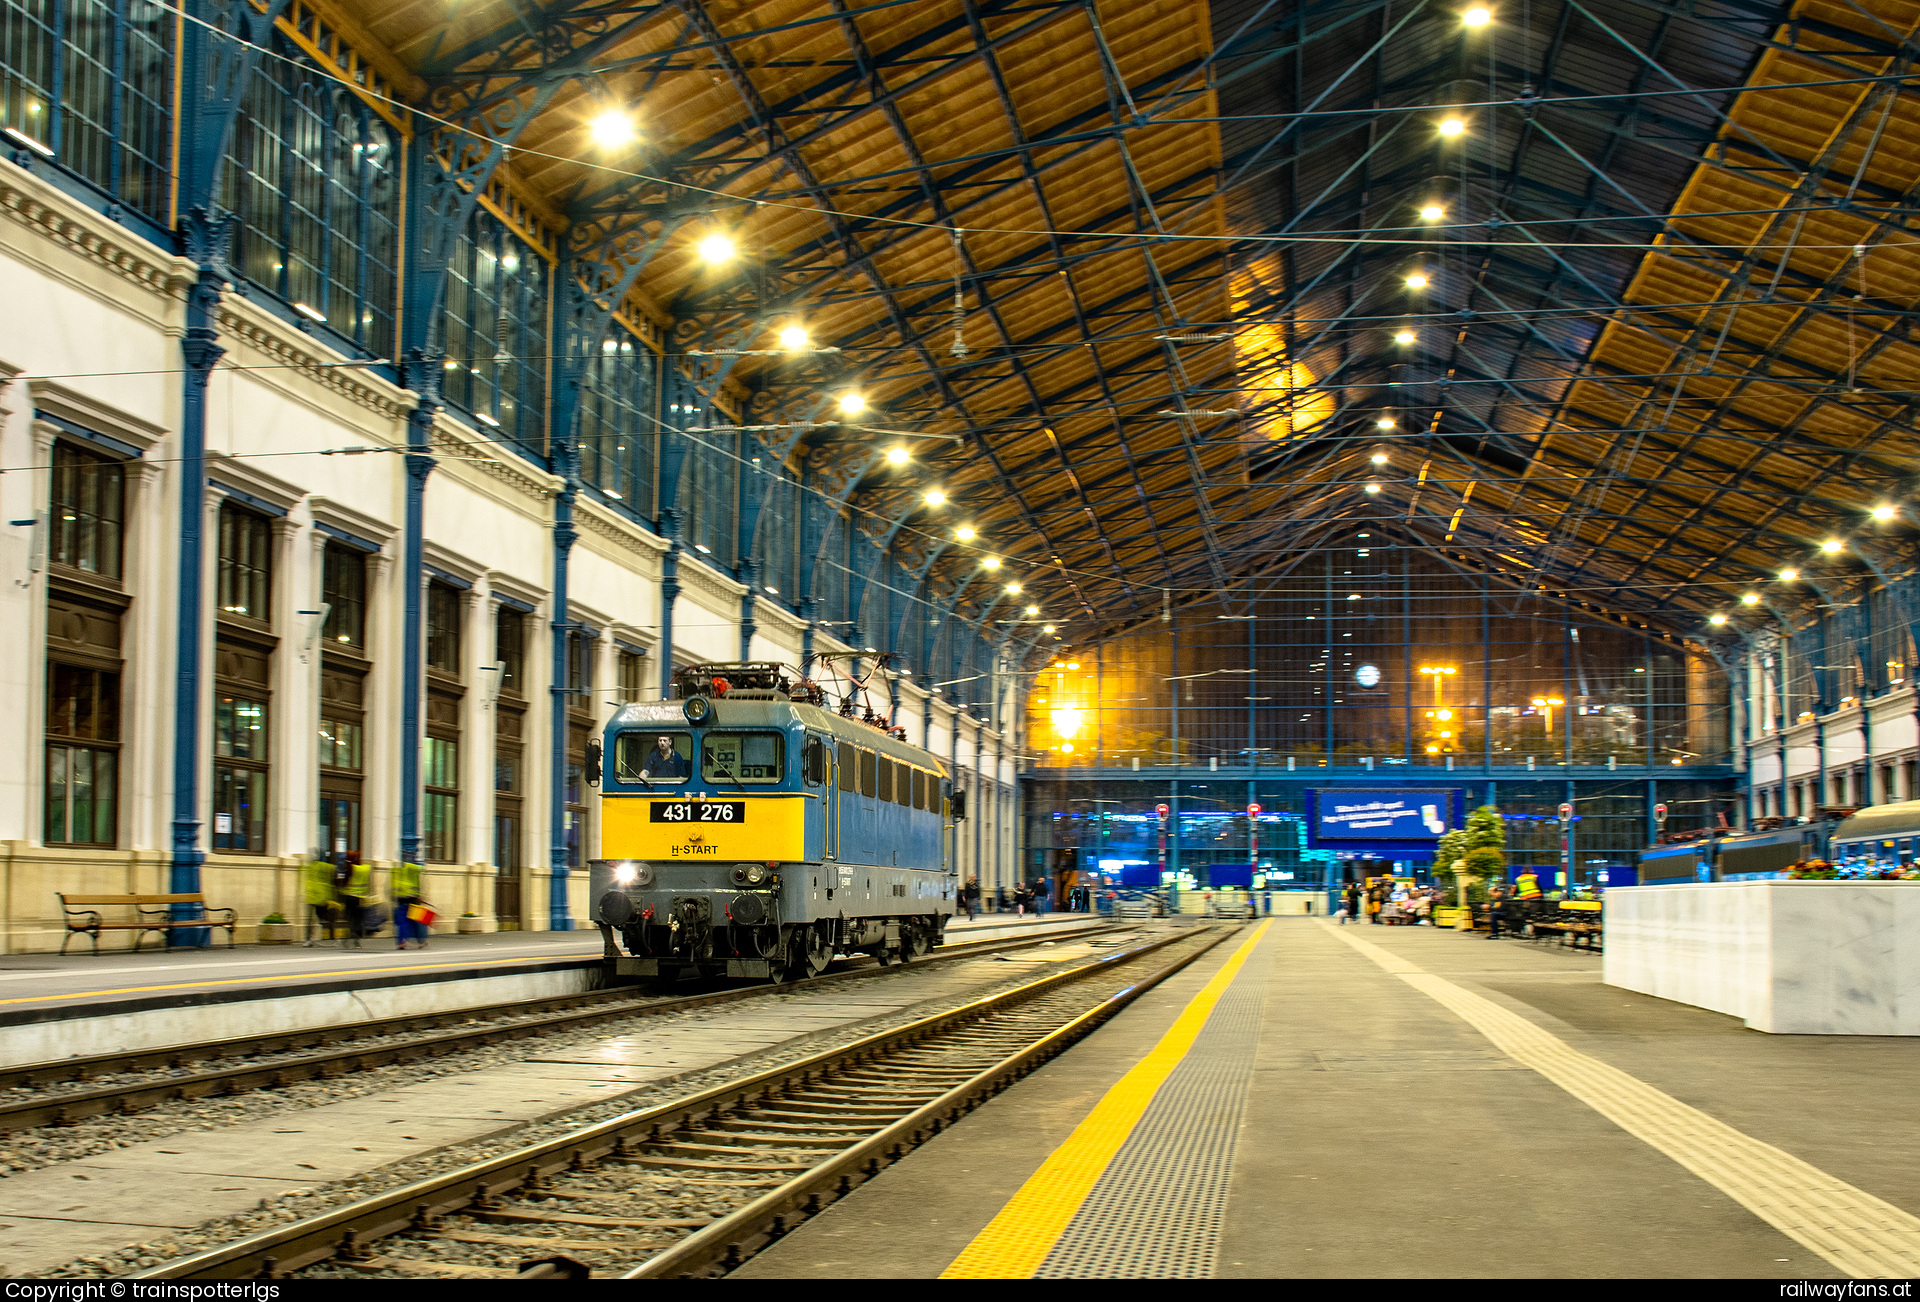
[1603,881,1920,1035]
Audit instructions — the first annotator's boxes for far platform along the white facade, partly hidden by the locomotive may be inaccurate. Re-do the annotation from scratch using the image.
[0,914,1098,1062]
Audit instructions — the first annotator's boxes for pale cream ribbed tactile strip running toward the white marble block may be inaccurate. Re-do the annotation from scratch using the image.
[1321,924,1920,1279]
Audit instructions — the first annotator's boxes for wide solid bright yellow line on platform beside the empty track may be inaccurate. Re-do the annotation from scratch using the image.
[941,922,1273,1279]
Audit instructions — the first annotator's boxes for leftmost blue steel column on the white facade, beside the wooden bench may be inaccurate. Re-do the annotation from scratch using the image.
[167,207,234,895]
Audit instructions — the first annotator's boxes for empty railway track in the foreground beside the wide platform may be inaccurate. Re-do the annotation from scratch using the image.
[129,928,1236,1279]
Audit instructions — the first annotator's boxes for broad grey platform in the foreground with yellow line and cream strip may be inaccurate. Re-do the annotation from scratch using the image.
[737,918,1920,1279]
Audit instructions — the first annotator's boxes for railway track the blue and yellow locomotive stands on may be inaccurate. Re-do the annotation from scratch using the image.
[0,928,1119,1137]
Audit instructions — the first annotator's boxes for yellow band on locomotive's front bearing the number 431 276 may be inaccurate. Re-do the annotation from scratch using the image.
[601,793,806,862]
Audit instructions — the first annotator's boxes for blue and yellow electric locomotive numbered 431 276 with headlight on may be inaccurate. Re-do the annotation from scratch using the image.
[589,663,966,981]
